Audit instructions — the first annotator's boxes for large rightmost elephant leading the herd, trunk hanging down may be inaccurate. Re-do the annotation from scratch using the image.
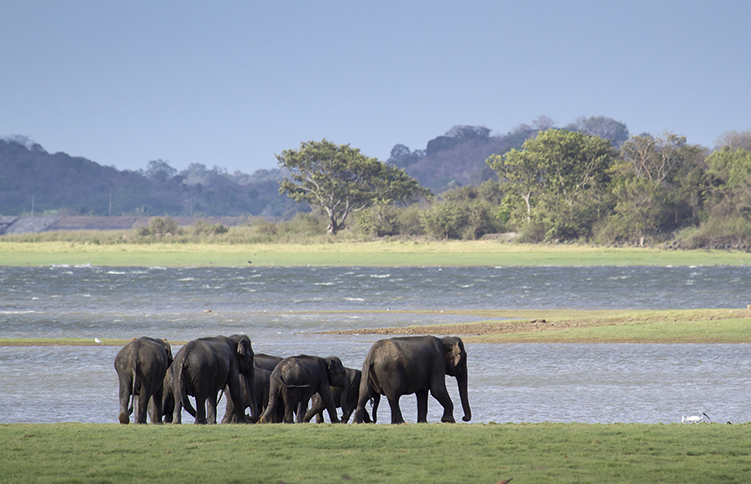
[355,336,472,424]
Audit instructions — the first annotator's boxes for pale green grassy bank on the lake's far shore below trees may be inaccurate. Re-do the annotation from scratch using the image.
[0,240,751,267]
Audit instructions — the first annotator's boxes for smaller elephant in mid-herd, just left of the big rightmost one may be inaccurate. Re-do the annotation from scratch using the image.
[260,355,347,423]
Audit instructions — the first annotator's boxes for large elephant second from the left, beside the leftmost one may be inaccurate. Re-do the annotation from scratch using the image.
[171,335,258,424]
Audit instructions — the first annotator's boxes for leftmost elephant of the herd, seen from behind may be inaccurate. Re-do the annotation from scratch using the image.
[115,336,172,424]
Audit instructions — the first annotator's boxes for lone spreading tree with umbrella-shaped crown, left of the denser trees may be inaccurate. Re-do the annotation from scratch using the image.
[276,139,428,234]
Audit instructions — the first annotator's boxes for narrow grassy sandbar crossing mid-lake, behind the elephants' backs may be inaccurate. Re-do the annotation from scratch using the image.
[0,308,751,346]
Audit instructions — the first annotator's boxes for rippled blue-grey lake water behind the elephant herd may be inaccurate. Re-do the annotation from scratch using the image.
[0,266,751,423]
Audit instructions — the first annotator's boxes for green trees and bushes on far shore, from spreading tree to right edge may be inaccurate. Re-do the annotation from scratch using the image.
[278,126,751,250]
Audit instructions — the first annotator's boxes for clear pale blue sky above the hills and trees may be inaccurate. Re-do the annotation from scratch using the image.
[0,0,751,173]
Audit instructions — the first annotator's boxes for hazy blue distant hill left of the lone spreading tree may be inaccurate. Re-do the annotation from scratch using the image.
[0,138,309,217]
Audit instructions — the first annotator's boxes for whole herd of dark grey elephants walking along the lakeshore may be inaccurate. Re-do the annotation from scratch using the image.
[115,335,472,424]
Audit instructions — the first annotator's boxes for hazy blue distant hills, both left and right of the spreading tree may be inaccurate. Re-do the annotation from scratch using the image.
[0,116,629,218]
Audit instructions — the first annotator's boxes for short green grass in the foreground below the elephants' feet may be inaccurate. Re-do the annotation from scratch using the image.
[0,423,751,484]
